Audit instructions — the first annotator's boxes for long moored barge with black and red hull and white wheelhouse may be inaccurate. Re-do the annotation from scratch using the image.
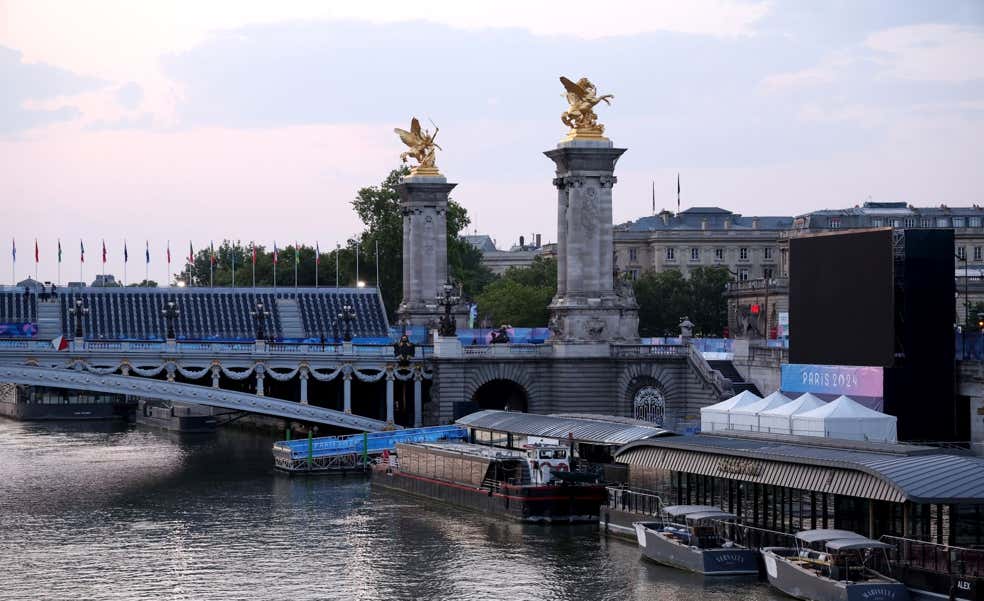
[372,442,607,523]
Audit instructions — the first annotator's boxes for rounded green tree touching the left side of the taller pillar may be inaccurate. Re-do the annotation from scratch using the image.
[476,257,557,327]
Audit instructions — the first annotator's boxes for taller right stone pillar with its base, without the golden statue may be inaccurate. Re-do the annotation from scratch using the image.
[544,138,639,356]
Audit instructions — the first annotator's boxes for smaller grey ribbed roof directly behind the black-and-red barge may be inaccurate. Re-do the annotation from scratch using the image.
[455,409,673,445]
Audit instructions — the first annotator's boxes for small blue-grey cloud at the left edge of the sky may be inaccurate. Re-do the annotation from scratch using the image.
[0,46,105,134]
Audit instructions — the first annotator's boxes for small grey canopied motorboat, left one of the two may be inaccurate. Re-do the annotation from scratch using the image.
[633,505,758,576]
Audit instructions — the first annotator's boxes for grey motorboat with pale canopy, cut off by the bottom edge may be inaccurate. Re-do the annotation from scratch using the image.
[762,529,910,601]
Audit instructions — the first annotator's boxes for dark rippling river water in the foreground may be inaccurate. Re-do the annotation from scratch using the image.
[0,418,782,601]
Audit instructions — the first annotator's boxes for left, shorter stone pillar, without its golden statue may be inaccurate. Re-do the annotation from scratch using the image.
[397,175,457,327]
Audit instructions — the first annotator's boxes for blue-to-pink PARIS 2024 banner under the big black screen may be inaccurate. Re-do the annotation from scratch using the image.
[781,363,885,397]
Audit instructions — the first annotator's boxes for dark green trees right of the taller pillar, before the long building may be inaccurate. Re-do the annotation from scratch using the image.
[634,267,731,337]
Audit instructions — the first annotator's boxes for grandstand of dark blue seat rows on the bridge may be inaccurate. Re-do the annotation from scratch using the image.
[0,288,389,342]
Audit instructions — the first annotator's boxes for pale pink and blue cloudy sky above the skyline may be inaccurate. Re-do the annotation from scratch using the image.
[0,0,984,283]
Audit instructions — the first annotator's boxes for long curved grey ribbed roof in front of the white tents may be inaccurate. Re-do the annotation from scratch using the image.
[615,432,984,504]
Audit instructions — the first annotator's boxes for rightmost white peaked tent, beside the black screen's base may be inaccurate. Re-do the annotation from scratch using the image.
[792,396,897,442]
